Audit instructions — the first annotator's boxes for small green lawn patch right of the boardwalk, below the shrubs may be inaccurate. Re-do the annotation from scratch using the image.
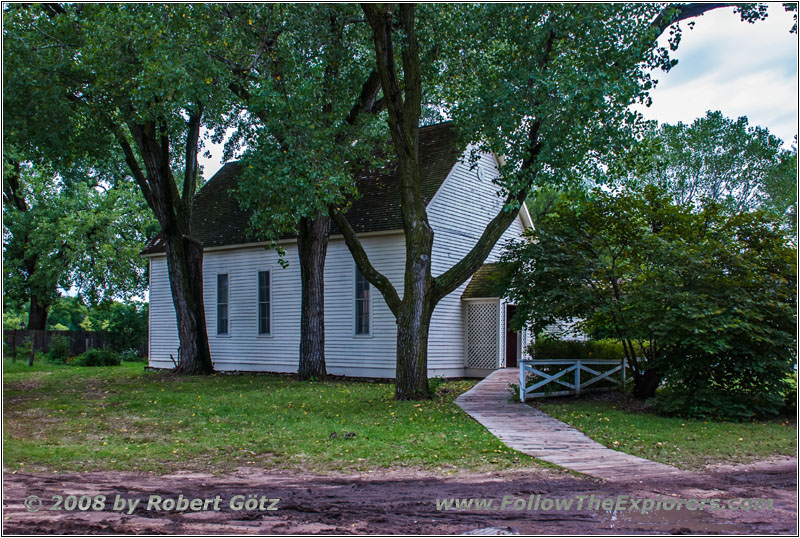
[532,393,797,469]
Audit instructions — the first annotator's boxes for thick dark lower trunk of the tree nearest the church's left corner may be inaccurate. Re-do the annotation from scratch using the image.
[164,233,214,374]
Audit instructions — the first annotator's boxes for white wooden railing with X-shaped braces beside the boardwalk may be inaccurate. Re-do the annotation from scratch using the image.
[519,359,627,402]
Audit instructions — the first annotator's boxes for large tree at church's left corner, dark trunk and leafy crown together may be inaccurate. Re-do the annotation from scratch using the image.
[3,3,256,373]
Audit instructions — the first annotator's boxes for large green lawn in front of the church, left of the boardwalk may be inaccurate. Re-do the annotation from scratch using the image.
[3,360,537,472]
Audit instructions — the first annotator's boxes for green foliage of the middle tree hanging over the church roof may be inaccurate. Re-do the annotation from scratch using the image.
[217,5,388,239]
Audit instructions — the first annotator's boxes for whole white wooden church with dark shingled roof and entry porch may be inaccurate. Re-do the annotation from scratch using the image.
[142,123,531,378]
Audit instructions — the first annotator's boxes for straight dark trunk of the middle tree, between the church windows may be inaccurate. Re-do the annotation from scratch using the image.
[297,213,330,379]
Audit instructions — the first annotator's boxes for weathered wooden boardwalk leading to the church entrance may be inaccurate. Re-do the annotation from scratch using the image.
[456,368,690,482]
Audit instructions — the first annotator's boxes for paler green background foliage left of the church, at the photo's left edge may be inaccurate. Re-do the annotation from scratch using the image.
[3,152,154,305]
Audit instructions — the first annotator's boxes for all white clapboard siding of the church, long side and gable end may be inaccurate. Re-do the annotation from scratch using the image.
[150,147,523,378]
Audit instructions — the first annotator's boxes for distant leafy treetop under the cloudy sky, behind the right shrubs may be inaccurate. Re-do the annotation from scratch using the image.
[609,111,797,219]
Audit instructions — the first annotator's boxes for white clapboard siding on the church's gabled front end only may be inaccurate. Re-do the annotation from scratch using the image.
[428,150,523,375]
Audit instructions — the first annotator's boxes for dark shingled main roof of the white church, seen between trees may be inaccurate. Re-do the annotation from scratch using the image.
[141,123,463,255]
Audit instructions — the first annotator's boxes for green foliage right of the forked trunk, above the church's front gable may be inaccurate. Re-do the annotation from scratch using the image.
[440,4,660,192]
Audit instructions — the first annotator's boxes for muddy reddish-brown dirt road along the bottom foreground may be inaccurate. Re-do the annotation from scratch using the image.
[3,459,797,534]
